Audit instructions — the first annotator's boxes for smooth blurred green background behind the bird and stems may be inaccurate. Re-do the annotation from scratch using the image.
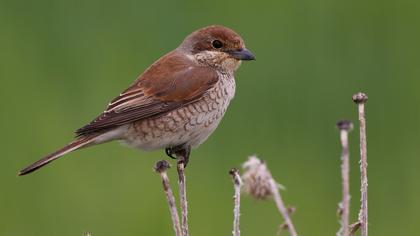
[0,0,420,236]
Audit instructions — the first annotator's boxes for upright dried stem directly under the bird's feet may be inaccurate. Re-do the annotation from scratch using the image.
[177,160,189,236]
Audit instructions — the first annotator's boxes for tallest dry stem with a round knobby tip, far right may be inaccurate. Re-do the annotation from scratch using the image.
[353,92,368,236]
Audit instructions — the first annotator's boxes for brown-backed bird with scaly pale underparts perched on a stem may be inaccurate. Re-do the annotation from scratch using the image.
[18,25,255,175]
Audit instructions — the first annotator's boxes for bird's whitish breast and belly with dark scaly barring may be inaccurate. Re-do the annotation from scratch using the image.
[123,74,235,150]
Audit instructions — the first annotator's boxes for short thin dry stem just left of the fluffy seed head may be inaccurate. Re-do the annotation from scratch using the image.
[229,168,242,236]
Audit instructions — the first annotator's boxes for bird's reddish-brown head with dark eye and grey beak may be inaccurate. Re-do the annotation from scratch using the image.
[178,25,255,72]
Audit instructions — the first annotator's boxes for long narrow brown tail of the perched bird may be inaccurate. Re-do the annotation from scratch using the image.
[19,136,97,175]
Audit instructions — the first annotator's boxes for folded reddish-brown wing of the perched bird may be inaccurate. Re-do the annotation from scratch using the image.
[76,51,218,136]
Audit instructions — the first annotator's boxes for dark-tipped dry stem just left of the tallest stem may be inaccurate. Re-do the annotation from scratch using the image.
[337,120,353,236]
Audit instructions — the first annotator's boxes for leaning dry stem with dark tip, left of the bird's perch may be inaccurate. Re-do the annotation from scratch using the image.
[154,160,182,236]
